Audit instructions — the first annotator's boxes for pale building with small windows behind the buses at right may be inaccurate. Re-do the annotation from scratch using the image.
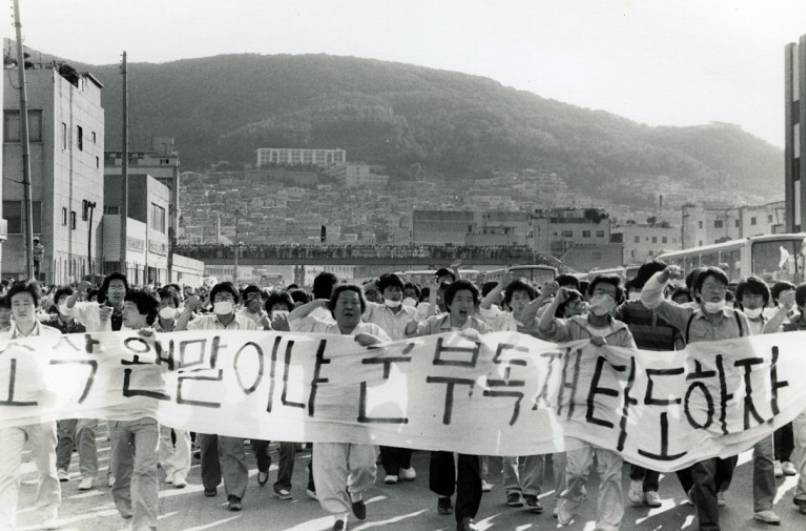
[680,201,786,249]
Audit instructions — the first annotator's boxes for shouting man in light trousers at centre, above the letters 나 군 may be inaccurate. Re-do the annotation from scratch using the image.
[289,284,390,531]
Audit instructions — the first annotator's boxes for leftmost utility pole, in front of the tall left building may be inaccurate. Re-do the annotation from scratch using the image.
[14,0,34,280]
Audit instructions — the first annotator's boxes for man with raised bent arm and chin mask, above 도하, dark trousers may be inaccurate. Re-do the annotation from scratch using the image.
[641,266,781,531]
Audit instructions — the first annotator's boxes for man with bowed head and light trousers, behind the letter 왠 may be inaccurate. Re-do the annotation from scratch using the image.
[110,290,165,531]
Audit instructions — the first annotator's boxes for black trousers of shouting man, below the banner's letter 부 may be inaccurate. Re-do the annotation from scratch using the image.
[428,452,481,523]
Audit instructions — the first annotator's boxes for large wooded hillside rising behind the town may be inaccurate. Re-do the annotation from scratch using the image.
[12,43,783,207]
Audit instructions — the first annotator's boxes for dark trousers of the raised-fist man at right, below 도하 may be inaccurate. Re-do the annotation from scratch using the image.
[677,456,739,531]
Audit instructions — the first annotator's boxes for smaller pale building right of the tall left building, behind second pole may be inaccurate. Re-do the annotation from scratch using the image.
[103,175,171,285]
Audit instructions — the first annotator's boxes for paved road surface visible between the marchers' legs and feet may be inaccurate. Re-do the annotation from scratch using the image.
[14,436,806,531]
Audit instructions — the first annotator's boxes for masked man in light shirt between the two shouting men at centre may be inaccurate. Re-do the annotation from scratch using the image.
[363,273,417,485]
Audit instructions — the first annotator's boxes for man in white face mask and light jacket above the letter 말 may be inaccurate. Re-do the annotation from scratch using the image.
[176,282,258,511]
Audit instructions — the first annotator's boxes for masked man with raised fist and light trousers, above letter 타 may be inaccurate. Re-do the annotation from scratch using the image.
[538,276,635,530]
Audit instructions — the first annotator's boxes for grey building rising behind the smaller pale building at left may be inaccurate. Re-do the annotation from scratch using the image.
[104,137,182,276]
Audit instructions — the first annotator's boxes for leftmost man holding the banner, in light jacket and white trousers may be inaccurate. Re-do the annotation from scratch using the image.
[0,282,62,529]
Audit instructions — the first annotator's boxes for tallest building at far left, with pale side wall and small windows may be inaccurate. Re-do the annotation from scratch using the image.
[2,64,104,284]
